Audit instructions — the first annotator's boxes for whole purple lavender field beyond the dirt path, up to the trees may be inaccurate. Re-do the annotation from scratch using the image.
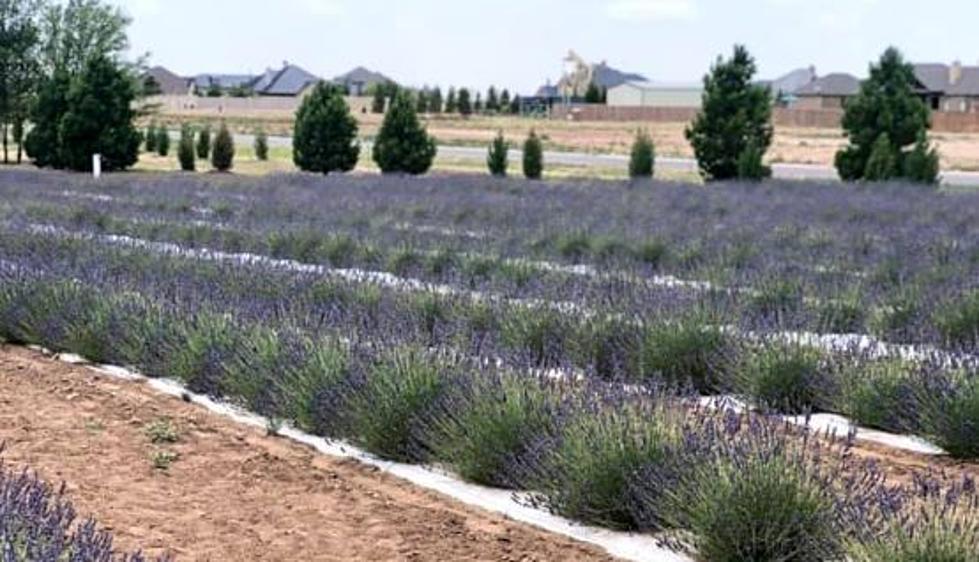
[0,168,979,561]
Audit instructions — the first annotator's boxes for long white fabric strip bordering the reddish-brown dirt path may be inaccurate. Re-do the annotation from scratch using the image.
[40,347,692,562]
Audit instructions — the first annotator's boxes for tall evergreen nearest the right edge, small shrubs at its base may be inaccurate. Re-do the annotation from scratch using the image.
[836,47,930,180]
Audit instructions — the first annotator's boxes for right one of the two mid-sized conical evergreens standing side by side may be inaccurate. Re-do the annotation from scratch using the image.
[374,92,437,175]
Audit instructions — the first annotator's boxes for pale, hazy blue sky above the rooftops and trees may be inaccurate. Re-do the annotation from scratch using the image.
[117,0,979,94]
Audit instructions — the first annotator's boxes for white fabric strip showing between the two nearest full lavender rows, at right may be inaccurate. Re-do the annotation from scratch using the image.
[700,395,948,456]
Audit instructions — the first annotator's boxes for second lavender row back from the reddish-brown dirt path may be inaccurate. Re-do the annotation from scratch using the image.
[0,230,979,458]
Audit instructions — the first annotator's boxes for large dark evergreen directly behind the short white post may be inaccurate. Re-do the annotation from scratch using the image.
[59,57,141,172]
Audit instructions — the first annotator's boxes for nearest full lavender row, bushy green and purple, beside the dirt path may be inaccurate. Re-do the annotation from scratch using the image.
[0,233,979,562]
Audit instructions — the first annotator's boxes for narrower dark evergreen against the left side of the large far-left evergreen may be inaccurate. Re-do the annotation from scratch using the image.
[24,70,71,168]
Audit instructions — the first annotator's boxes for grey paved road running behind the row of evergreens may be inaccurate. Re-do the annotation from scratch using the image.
[216,130,979,187]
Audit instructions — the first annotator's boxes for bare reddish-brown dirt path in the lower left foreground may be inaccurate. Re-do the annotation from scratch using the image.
[0,346,610,562]
